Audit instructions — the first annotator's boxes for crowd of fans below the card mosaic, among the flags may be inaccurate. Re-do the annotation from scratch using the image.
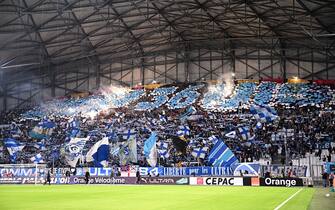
[0,81,335,166]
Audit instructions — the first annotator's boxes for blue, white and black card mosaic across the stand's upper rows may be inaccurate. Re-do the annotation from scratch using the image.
[24,82,335,117]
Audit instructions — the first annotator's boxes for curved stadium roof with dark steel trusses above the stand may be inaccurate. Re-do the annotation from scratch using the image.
[0,0,335,74]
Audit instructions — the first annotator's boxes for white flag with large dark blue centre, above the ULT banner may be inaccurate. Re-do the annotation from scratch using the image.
[86,137,109,167]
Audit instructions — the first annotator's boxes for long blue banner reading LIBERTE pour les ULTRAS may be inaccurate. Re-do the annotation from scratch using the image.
[139,166,232,177]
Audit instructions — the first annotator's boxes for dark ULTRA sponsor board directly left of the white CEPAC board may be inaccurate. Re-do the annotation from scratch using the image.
[140,177,189,185]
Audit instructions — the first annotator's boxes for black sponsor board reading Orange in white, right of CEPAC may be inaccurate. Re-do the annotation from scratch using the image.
[259,178,303,187]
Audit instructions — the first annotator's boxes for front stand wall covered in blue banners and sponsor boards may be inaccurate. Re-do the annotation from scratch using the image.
[0,163,311,187]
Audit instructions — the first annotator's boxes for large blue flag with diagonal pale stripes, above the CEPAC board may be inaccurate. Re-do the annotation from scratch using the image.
[208,140,238,167]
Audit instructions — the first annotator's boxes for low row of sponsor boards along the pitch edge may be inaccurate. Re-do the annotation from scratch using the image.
[0,176,311,187]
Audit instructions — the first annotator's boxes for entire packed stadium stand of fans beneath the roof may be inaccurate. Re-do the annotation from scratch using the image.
[0,81,335,179]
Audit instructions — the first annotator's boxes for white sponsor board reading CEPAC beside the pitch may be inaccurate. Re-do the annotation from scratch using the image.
[190,177,243,186]
